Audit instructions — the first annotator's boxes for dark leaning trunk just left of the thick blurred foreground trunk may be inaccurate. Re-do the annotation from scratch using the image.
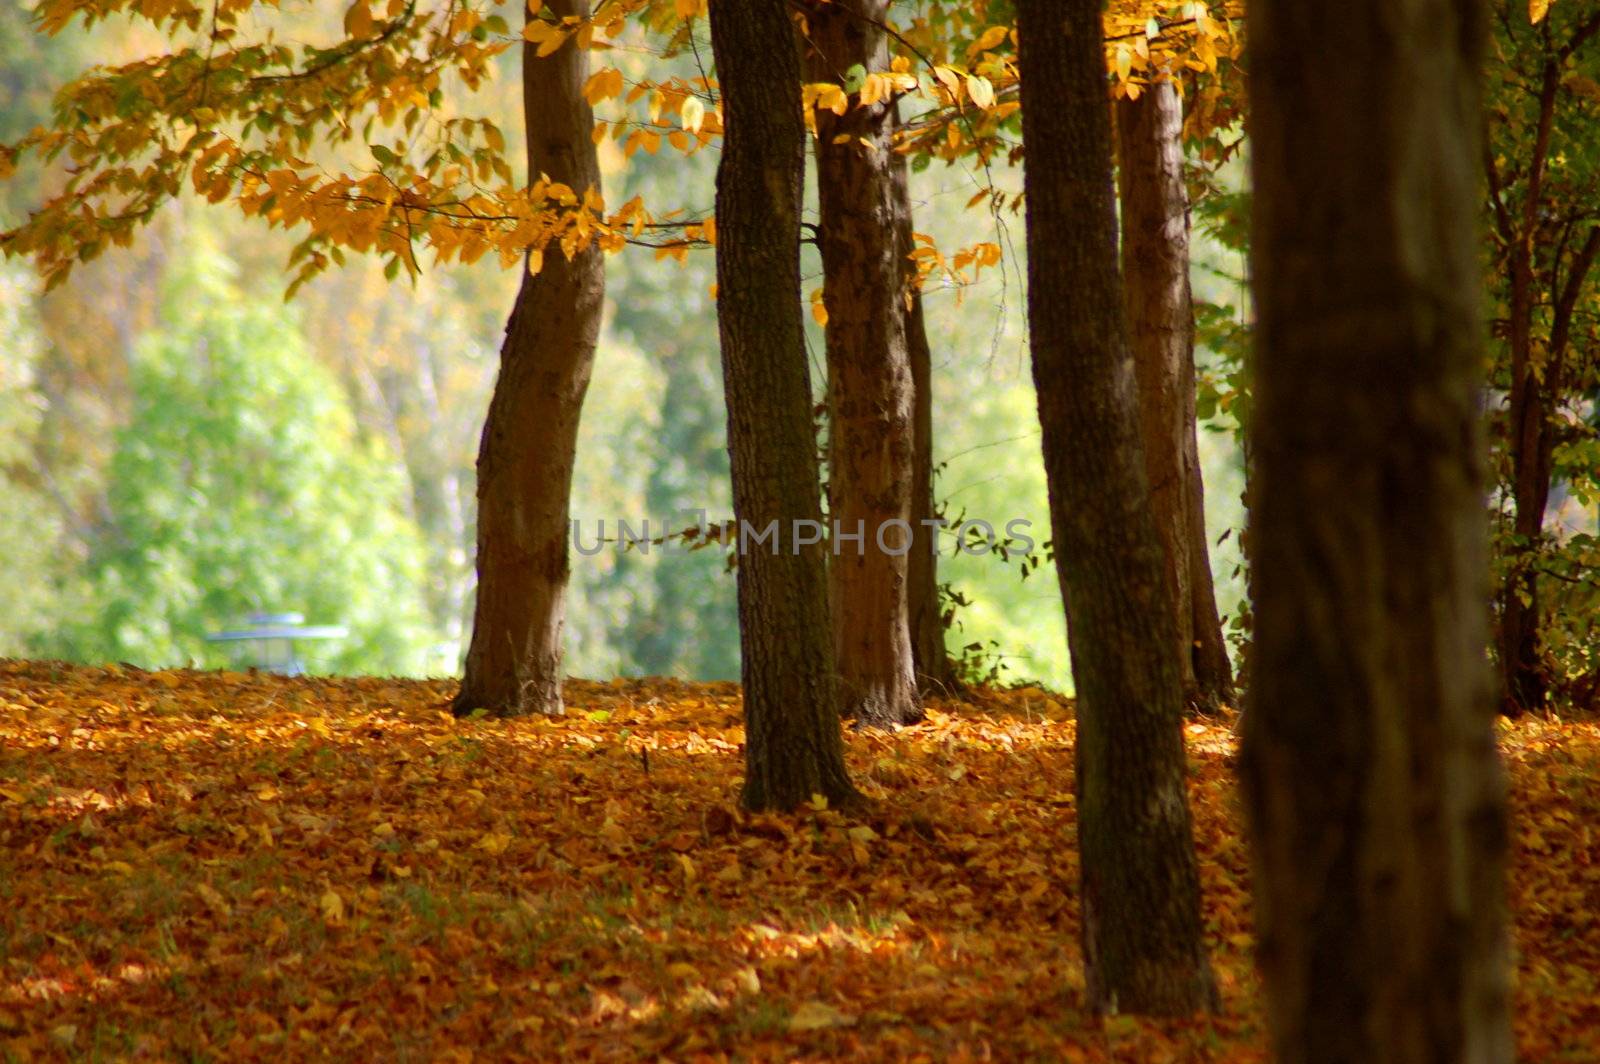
[1016,0,1216,1014]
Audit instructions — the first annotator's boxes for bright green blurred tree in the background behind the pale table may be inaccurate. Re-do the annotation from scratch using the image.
[45,238,444,672]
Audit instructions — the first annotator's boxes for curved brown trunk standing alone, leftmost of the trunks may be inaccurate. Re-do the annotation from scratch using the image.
[454,0,605,717]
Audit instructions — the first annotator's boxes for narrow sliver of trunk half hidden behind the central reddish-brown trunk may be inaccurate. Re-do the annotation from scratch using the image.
[890,126,955,694]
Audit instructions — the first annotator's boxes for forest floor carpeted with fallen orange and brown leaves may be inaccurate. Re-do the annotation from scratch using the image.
[0,662,1600,1064]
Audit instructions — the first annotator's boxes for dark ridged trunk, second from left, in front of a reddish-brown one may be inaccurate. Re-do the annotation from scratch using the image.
[710,0,858,810]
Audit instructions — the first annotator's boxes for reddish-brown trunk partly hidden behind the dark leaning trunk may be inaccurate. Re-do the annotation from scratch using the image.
[1117,82,1234,712]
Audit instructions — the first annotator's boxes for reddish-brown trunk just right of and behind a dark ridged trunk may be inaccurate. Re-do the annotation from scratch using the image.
[806,0,922,725]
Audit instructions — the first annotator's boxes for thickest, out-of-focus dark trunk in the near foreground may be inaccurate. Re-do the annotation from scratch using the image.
[1242,0,1512,1064]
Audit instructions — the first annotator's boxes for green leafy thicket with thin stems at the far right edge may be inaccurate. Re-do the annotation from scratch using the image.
[1485,0,1600,709]
